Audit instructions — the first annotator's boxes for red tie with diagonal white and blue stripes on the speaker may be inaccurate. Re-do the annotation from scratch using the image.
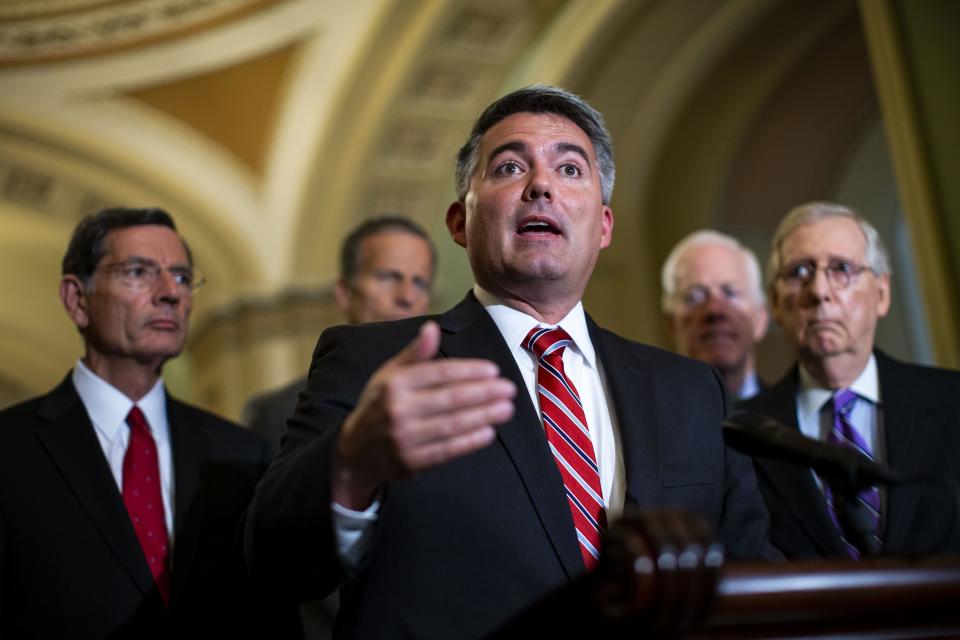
[523,327,606,569]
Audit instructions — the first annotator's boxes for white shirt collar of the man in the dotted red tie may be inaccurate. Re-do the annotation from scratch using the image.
[72,360,167,442]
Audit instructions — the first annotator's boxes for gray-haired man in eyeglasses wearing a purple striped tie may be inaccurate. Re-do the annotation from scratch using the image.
[744,202,960,558]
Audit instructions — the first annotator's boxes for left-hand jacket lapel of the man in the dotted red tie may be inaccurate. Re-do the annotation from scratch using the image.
[37,376,154,596]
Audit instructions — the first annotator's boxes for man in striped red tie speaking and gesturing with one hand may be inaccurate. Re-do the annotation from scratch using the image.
[245,86,767,638]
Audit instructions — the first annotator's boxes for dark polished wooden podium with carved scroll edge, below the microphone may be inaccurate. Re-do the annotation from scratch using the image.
[493,511,960,639]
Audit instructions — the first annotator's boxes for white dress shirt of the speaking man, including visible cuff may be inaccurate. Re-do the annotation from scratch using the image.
[331,285,626,567]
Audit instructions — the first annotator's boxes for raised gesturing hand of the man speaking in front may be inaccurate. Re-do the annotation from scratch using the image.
[333,322,517,509]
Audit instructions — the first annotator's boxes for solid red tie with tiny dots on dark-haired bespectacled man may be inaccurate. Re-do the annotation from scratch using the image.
[123,406,170,604]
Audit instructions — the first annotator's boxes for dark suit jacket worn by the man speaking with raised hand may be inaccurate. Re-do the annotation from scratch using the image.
[245,294,767,638]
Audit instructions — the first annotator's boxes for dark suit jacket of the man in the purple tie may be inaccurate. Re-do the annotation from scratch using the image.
[741,351,960,559]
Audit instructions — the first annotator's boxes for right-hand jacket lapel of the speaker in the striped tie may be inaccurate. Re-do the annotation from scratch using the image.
[587,324,661,506]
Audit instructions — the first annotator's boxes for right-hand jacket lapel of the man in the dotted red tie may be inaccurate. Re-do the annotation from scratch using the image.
[167,395,206,605]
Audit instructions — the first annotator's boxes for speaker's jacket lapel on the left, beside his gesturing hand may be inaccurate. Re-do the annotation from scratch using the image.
[440,293,583,577]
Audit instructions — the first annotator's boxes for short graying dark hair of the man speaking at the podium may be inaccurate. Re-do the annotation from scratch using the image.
[454,84,616,204]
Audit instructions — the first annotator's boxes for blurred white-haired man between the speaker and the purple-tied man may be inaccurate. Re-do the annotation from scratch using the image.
[660,229,768,399]
